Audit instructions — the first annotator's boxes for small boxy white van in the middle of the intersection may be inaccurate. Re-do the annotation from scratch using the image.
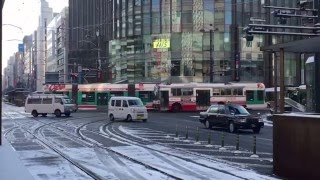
[108,96,148,122]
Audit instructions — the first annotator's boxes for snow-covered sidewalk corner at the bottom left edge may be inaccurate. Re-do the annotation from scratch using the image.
[0,137,34,180]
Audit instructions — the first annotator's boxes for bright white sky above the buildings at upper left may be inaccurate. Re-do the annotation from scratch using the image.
[2,0,68,72]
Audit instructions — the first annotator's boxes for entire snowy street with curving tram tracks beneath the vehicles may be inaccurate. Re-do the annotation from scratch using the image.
[2,104,275,179]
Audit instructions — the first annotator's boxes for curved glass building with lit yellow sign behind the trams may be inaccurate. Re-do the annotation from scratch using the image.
[107,0,312,87]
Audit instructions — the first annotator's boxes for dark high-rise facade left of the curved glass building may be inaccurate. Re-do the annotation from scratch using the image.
[68,0,112,83]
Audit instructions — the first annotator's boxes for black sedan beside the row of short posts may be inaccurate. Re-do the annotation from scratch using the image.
[199,104,264,133]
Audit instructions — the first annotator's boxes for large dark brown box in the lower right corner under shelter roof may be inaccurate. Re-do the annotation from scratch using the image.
[273,114,320,179]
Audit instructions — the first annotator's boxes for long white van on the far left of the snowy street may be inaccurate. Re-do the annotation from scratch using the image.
[25,94,76,117]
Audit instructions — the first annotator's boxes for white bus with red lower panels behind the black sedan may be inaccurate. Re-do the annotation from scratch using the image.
[155,83,267,111]
